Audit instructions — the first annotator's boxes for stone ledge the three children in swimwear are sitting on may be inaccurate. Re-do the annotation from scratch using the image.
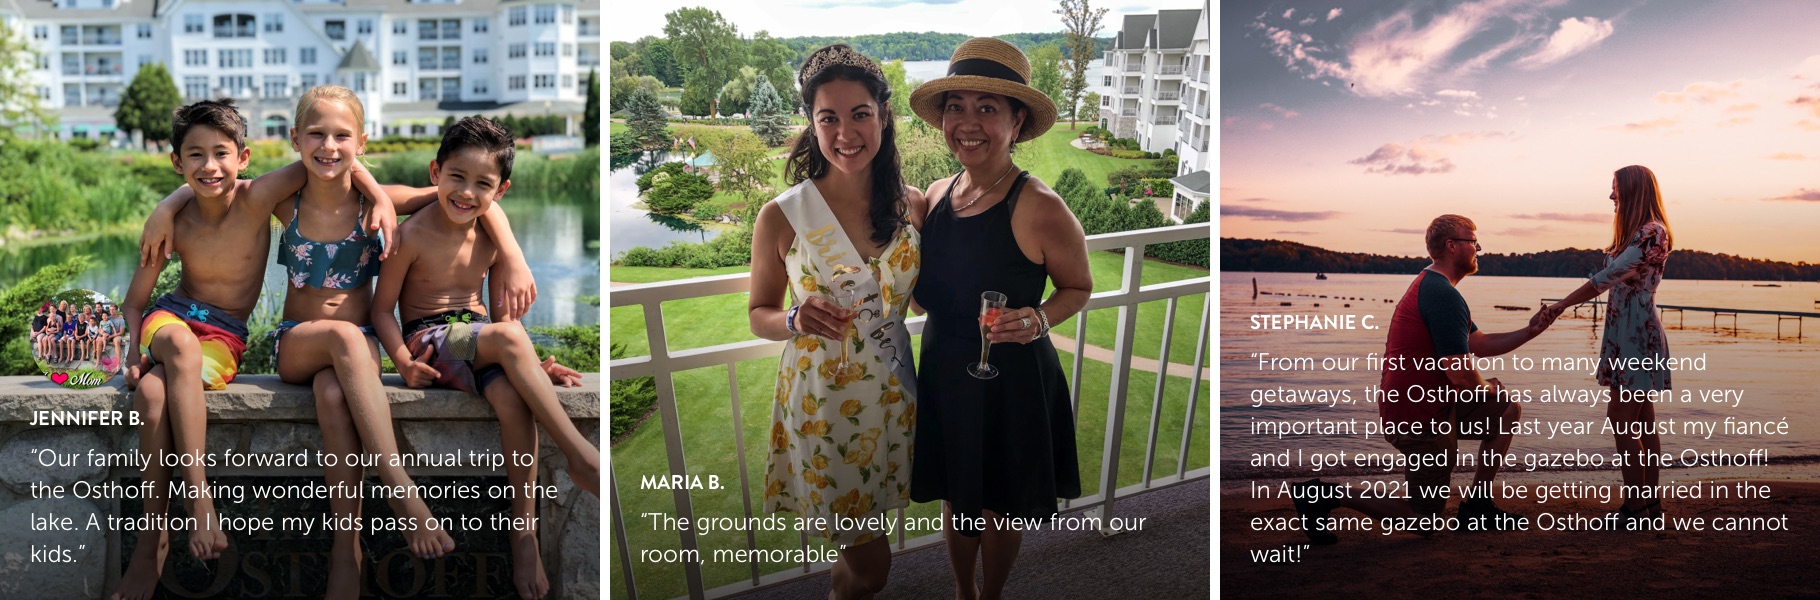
[0,373,604,598]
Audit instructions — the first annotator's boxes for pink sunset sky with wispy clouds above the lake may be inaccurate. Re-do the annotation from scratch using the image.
[1219,0,1820,262]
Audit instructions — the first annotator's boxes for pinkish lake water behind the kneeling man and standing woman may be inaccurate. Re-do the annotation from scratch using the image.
[1219,272,1820,478]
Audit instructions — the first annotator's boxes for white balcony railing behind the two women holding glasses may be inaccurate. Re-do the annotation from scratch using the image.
[608,224,1214,598]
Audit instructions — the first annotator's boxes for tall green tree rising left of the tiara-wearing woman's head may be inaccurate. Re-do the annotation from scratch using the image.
[664,7,746,116]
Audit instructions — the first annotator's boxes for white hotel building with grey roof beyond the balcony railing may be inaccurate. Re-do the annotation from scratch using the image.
[1099,2,1214,222]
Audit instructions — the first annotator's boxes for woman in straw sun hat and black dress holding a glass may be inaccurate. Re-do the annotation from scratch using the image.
[910,38,1094,598]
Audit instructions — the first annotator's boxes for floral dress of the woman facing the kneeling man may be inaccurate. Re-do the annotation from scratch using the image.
[1591,222,1671,391]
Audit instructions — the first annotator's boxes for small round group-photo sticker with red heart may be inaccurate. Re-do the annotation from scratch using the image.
[27,289,131,389]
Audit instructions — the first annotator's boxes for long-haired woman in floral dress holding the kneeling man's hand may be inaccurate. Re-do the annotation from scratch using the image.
[1545,165,1674,527]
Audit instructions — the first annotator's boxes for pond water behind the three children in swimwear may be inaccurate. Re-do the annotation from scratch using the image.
[0,195,601,325]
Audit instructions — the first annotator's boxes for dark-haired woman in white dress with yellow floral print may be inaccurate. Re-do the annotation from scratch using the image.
[746,44,923,600]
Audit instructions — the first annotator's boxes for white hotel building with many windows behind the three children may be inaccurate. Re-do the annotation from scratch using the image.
[10,0,601,138]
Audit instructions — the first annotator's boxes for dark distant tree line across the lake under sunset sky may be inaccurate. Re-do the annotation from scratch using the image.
[1219,238,1820,282]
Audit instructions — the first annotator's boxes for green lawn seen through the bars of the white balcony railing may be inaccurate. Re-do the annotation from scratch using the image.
[608,343,1212,598]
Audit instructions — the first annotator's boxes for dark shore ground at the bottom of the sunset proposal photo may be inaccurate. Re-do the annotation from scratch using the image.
[1219,469,1820,598]
